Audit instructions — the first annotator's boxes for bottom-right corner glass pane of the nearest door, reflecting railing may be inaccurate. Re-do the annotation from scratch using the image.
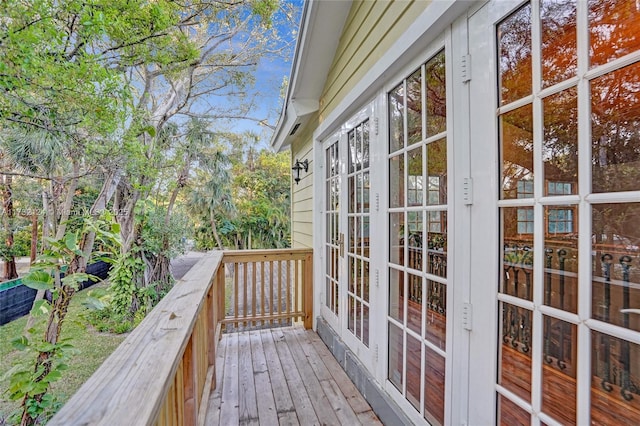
[591,331,640,425]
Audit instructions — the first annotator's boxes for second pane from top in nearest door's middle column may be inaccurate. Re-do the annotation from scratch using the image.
[542,87,578,195]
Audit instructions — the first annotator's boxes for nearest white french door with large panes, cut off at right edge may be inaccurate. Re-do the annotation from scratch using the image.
[468,0,640,425]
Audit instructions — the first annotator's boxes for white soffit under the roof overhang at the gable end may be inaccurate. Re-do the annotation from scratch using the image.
[271,0,351,151]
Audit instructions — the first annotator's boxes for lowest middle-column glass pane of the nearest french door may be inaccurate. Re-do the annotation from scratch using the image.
[542,316,577,424]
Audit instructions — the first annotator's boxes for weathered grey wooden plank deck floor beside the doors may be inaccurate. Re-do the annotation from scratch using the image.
[205,327,381,426]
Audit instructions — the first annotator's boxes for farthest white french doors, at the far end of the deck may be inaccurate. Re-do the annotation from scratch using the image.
[322,105,373,367]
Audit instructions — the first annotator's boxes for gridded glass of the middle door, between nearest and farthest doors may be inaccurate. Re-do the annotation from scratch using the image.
[387,51,449,424]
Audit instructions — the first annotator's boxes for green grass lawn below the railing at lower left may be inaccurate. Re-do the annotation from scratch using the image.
[0,283,126,424]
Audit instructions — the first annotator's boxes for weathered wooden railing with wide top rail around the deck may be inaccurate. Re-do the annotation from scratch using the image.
[49,249,313,425]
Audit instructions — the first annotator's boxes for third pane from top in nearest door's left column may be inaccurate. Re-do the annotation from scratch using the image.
[500,207,534,300]
